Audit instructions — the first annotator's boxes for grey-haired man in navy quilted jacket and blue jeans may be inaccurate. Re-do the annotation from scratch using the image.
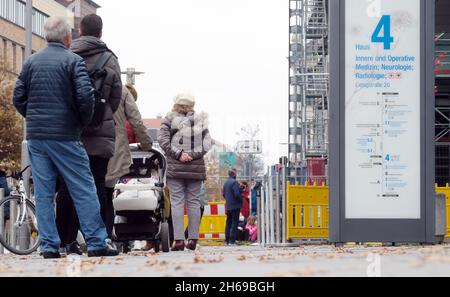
[13,17,118,259]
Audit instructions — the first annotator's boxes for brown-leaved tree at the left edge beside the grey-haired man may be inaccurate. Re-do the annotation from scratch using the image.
[0,61,23,170]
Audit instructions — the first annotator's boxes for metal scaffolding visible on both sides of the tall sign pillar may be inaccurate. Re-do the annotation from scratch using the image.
[289,0,450,186]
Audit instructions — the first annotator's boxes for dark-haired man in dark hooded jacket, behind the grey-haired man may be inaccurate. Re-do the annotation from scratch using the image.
[57,14,122,250]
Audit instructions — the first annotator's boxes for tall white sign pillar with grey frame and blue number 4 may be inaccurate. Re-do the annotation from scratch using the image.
[329,0,435,243]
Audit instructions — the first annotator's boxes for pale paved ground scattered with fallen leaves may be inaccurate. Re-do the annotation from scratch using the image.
[0,245,450,277]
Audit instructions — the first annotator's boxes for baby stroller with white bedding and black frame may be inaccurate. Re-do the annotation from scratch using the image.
[113,146,170,253]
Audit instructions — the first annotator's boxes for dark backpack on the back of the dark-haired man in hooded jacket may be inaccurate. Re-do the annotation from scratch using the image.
[88,52,113,130]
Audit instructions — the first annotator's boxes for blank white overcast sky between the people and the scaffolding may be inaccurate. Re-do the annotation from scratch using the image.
[96,0,288,163]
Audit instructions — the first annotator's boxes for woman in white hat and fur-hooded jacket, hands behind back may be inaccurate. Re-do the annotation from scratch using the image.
[158,94,212,251]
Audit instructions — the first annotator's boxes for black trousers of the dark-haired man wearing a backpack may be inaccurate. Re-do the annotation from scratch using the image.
[56,156,114,246]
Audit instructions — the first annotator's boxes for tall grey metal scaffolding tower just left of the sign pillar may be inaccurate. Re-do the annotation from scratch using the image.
[289,0,329,178]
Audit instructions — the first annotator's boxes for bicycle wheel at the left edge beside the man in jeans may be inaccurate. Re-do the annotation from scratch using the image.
[0,197,40,255]
